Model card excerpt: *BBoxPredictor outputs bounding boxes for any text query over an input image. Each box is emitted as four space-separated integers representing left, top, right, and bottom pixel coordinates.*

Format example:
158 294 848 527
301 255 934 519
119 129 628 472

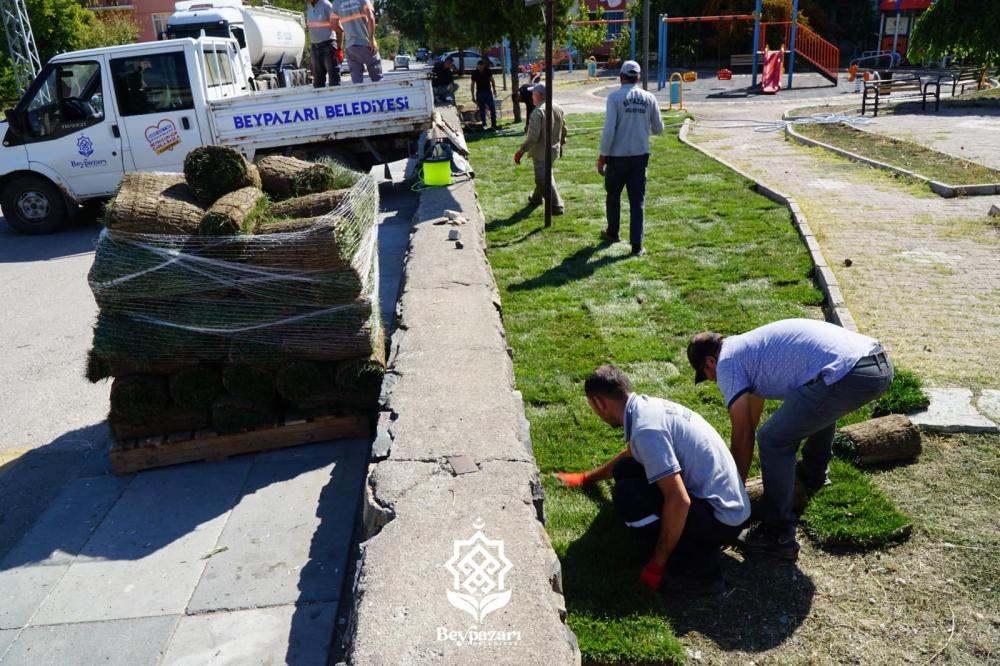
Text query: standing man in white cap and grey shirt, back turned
597 60 663 256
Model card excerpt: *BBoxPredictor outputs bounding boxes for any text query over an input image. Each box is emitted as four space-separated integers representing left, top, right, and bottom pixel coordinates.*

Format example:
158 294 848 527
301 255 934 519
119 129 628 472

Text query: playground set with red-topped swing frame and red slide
657 0 840 93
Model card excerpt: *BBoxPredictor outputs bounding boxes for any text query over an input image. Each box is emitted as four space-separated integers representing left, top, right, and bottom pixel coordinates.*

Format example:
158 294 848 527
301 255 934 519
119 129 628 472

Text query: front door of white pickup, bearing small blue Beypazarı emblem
14 56 123 200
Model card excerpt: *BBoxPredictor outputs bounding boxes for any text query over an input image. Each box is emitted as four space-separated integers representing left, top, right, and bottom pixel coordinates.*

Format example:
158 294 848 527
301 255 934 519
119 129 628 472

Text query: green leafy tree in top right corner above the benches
907 0 1000 66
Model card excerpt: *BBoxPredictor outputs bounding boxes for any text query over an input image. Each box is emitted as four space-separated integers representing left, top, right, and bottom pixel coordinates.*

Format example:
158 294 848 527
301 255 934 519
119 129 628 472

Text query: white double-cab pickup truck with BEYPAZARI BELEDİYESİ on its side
0 37 434 233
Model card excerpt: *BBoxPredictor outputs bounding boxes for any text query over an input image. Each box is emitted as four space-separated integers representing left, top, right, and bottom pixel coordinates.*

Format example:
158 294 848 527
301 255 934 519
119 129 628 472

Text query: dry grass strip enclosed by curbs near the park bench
795 124 1000 185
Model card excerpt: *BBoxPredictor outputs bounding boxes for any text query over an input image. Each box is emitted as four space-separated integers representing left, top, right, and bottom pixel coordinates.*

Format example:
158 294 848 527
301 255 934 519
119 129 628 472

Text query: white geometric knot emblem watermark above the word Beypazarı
444 518 514 622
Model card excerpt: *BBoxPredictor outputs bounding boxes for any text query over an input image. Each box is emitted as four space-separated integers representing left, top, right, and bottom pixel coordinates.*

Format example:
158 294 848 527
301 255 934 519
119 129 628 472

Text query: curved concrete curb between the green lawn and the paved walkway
677 118 858 331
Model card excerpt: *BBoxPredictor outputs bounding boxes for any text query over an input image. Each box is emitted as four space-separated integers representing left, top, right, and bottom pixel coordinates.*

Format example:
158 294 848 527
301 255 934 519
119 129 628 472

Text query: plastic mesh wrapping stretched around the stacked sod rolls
89 166 383 366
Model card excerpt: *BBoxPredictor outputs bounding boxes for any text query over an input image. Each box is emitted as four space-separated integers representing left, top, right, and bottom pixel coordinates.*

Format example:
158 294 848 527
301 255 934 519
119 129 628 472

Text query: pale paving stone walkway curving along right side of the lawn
690 103 1000 391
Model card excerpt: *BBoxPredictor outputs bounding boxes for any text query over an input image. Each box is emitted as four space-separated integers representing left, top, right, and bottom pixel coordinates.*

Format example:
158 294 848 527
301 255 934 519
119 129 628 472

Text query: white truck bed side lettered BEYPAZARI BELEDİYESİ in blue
208 72 434 154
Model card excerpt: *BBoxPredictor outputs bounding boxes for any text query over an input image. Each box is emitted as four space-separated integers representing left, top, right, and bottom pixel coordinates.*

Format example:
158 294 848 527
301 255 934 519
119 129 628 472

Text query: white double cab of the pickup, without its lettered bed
0 39 247 233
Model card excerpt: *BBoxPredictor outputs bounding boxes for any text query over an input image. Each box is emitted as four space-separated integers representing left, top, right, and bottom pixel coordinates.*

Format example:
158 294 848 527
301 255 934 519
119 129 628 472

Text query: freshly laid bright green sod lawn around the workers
469 115 912 664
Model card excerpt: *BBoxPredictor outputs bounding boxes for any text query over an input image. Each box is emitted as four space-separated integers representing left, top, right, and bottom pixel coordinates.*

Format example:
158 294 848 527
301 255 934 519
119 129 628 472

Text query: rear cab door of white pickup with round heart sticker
109 50 201 171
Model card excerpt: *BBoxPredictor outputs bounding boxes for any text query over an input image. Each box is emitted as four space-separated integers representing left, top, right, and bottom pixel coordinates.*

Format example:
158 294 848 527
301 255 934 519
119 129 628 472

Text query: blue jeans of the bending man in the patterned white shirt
757 352 893 538
